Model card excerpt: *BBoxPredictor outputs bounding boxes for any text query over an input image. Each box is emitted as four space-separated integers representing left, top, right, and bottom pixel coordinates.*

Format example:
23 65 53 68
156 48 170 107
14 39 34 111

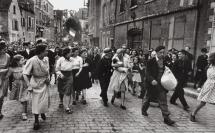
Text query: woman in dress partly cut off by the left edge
0 41 10 120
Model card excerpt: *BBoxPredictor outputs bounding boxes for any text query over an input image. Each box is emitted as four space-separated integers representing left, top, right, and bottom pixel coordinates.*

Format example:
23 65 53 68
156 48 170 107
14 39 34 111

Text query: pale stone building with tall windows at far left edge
0 0 22 42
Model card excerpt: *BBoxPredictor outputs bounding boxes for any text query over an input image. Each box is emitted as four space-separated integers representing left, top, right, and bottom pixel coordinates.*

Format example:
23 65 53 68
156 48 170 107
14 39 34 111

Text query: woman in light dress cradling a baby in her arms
108 49 129 110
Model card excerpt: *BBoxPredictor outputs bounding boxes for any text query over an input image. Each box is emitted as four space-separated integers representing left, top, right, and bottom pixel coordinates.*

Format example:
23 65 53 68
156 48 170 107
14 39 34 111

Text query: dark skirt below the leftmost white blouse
58 71 73 96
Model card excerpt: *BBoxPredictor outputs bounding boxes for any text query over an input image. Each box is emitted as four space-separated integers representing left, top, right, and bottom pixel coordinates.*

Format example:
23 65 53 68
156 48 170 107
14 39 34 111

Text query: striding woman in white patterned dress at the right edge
190 53 215 122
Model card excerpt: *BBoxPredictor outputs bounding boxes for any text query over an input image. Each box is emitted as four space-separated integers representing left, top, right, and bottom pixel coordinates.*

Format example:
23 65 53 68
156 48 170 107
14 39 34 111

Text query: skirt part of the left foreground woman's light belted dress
32 85 49 114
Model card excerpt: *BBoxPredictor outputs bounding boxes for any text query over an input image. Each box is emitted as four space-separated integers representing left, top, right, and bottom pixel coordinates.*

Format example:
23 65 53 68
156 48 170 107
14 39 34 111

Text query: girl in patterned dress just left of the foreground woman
7 55 30 121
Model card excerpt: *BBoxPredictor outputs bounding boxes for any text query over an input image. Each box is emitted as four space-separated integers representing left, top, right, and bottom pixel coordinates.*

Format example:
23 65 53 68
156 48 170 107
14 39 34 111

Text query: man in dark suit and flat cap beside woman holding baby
97 48 112 107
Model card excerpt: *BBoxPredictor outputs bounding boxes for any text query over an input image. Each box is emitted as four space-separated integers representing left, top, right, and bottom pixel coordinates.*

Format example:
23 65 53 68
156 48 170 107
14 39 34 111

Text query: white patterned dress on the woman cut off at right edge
198 66 215 103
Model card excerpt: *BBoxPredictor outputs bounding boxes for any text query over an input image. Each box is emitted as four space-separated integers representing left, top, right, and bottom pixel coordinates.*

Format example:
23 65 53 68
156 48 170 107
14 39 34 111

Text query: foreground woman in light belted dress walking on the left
23 44 50 130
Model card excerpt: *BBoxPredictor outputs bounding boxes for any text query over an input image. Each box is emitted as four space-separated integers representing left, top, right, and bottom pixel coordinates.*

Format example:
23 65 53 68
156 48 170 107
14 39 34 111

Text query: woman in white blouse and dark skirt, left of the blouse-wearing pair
56 48 74 114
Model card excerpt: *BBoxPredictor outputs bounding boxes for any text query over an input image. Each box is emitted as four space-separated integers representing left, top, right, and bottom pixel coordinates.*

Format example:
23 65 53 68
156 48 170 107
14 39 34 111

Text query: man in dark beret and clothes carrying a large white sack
142 46 175 125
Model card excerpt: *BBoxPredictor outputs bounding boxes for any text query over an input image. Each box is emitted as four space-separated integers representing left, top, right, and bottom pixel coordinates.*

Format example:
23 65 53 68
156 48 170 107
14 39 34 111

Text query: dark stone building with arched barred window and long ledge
115 0 198 53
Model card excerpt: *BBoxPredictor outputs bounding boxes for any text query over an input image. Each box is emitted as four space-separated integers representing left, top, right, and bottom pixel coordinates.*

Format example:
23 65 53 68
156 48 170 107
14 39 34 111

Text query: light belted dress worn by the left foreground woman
23 56 50 114
